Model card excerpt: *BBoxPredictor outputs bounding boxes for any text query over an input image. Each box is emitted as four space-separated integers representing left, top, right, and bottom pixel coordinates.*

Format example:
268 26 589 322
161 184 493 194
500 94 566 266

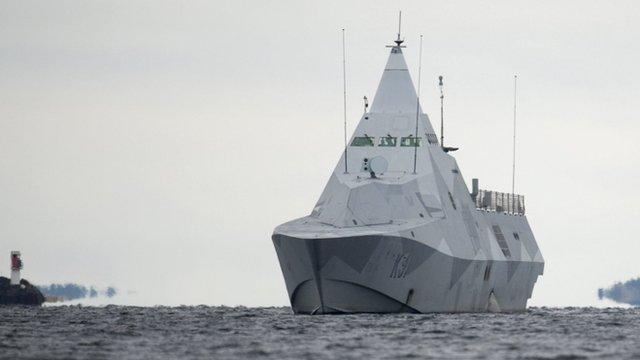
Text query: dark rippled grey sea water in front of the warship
0 306 640 359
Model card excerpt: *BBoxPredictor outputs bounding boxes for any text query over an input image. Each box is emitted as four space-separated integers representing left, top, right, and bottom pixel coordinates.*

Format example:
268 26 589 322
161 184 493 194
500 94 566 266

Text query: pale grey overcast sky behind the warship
0 1 640 305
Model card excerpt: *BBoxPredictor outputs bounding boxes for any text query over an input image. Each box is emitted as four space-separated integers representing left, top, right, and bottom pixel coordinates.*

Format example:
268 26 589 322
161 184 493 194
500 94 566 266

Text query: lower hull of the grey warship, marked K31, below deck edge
273 235 543 314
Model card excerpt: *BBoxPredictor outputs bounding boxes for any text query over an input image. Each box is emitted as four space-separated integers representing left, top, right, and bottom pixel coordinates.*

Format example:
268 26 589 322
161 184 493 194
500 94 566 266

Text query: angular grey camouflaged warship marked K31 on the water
272 26 544 314
